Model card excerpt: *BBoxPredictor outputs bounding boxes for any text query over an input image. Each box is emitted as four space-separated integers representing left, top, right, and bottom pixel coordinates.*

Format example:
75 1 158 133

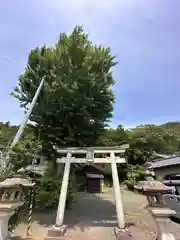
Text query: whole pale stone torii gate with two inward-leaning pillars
45 144 129 240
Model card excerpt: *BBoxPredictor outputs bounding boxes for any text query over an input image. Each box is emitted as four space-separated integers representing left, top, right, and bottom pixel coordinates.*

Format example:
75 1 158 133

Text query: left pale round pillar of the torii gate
55 153 71 227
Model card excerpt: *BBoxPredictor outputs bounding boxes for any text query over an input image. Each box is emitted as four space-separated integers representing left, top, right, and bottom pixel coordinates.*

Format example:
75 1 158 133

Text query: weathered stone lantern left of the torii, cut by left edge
0 169 34 240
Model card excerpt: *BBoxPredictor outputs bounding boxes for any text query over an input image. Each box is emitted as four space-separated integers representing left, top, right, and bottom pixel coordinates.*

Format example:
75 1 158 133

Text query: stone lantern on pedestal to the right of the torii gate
143 180 176 240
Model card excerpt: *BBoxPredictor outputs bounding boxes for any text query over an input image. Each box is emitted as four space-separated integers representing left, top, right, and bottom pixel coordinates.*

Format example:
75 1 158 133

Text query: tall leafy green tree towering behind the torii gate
13 26 116 150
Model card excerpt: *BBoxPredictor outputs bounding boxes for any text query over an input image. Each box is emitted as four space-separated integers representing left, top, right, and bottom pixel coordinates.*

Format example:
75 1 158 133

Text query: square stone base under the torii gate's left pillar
44 225 67 240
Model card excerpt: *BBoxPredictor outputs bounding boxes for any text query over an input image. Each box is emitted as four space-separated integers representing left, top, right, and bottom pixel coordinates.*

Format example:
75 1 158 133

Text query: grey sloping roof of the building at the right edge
149 156 180 169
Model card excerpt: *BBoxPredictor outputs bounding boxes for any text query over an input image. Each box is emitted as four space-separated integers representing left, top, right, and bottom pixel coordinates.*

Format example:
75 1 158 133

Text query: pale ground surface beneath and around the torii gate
16 189 180 240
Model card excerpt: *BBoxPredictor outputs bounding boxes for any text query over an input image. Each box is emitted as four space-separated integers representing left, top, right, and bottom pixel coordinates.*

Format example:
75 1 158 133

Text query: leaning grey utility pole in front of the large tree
10 77 44 149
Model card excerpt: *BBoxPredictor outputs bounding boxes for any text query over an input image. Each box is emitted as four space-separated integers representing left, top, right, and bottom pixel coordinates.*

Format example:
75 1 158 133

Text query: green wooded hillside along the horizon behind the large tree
0 122 180 154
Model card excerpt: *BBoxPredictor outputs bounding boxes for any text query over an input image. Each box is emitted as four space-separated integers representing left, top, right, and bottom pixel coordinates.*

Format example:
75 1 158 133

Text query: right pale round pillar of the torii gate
110 152 125 229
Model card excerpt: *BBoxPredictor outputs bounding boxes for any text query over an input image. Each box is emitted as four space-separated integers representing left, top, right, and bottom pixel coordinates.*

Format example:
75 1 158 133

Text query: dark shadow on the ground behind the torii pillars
30 190 117 231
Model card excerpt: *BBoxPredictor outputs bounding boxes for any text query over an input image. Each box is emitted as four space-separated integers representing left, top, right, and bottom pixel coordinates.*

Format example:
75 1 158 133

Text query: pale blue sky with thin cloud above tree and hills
0 0 180 127
